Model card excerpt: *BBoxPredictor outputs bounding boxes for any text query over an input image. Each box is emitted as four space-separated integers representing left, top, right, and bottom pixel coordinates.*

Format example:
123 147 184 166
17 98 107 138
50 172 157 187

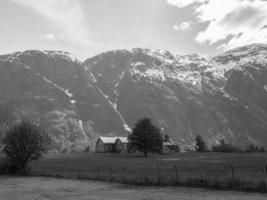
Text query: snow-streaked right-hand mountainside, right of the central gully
85 45 267 146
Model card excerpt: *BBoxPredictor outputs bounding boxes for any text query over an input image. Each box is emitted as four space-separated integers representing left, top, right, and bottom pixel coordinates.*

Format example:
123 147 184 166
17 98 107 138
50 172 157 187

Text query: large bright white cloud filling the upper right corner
167 0 267 49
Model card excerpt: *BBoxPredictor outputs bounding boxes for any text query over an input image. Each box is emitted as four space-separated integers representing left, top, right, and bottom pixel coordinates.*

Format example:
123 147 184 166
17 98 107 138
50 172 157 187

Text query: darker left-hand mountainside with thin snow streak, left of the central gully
0 51 127 152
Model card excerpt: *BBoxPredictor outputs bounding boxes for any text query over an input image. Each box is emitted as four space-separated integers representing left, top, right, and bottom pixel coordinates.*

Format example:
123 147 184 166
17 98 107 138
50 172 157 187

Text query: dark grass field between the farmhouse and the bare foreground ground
32 153 267 192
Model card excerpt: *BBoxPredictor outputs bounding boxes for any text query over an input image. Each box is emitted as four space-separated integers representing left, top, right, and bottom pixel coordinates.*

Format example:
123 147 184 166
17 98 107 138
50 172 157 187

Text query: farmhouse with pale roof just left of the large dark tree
95 137 128 153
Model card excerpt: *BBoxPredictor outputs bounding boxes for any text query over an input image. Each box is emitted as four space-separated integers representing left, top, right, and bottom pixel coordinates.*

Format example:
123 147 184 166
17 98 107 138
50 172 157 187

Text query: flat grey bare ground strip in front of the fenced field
0 176 267 200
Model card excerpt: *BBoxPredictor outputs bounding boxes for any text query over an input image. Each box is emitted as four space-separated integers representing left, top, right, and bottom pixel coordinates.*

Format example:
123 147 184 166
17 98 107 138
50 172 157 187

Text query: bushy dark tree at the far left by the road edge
3 121 50 174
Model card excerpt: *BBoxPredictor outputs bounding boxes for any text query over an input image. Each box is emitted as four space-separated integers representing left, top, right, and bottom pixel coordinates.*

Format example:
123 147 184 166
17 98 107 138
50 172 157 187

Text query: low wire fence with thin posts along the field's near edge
32 164 267 192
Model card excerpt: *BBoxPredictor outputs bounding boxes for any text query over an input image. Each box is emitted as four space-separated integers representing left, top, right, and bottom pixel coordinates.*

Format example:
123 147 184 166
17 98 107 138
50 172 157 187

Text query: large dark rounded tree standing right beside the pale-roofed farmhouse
128 118 163 157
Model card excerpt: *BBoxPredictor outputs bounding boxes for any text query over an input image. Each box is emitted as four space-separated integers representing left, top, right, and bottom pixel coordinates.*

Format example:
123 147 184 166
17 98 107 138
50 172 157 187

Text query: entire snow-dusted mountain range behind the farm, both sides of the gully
0 44 267 152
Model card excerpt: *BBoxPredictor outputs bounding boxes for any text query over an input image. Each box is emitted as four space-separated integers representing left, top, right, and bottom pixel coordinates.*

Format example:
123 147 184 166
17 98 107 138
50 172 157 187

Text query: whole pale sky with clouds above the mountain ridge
0 0 267 60
